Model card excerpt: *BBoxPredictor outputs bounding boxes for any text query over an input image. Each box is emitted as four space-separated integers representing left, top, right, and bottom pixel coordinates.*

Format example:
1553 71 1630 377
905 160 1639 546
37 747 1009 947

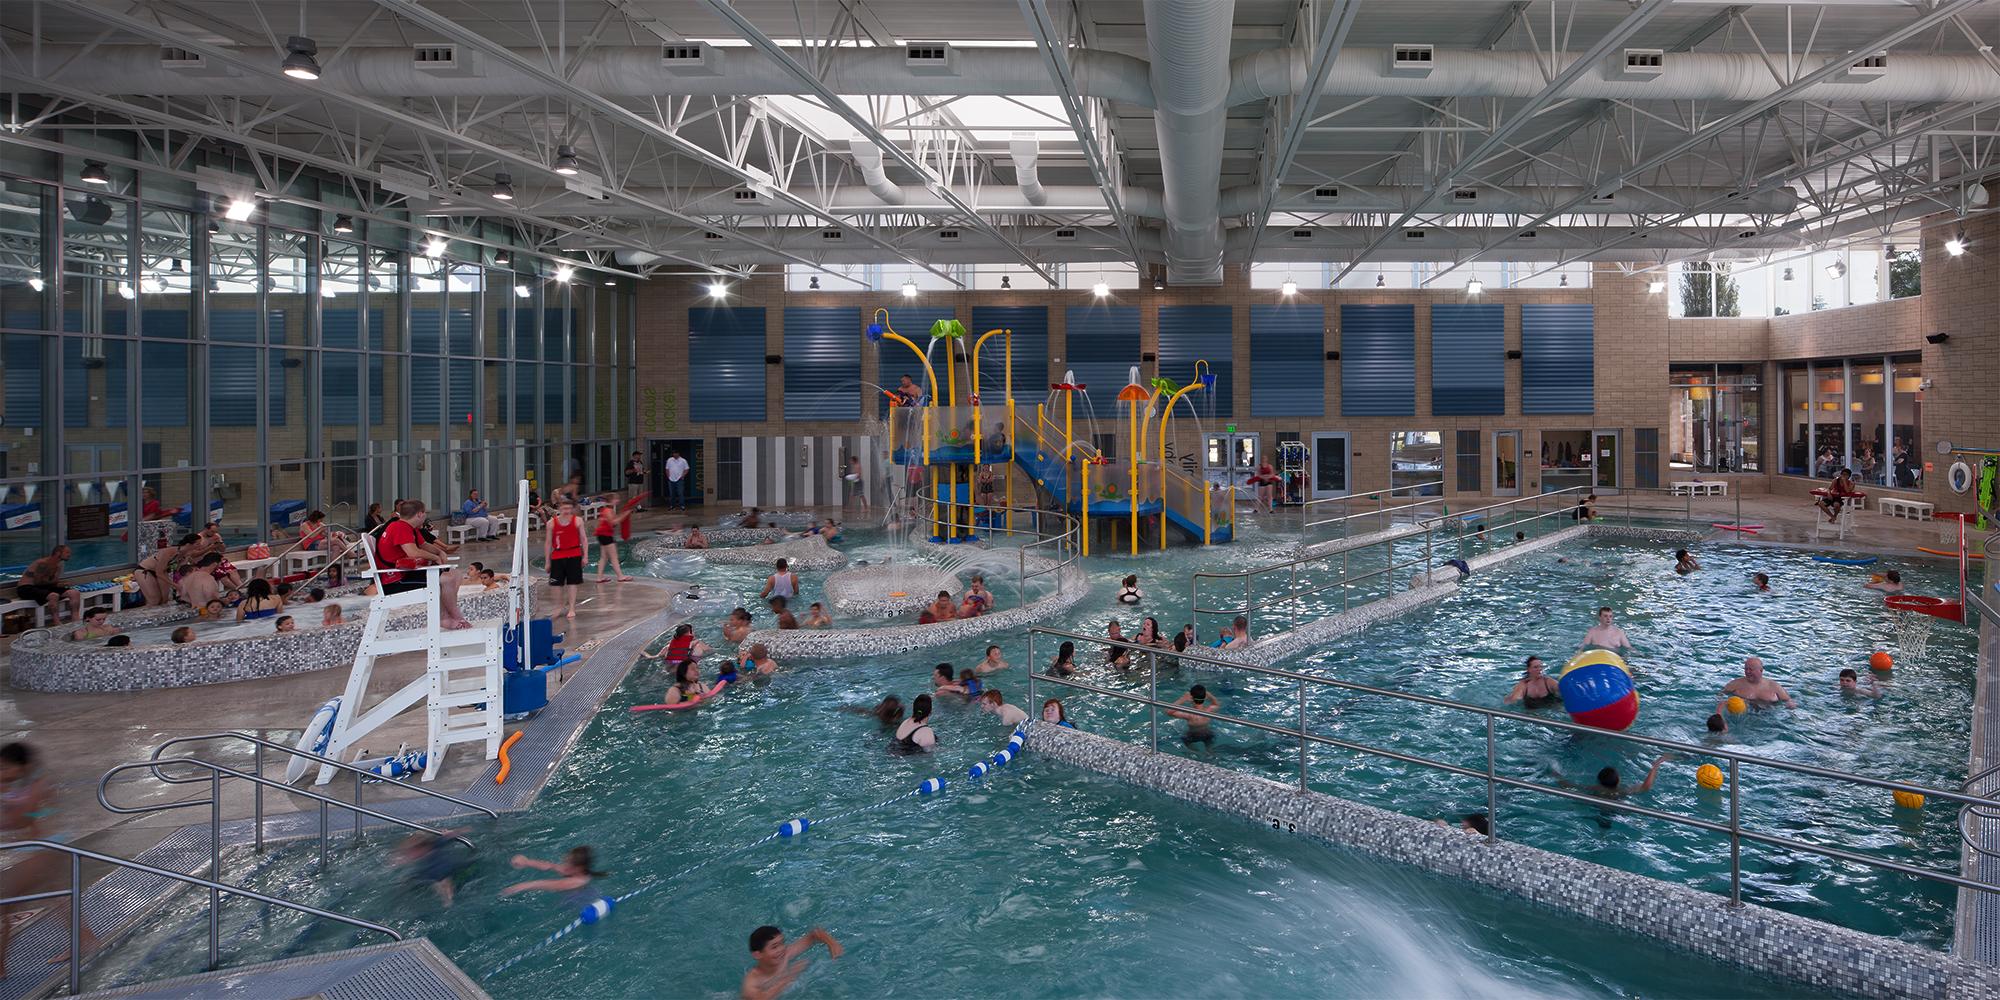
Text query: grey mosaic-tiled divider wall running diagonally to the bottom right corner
1028 722 2000 998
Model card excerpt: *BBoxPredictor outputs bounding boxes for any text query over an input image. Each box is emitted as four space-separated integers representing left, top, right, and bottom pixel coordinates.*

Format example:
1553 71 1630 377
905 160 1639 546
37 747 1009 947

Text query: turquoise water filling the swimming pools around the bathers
74 516 1972 996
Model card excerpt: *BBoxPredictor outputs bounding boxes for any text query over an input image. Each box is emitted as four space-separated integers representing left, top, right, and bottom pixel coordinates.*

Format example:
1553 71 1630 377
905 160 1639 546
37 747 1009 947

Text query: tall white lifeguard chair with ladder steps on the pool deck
302 482 528 784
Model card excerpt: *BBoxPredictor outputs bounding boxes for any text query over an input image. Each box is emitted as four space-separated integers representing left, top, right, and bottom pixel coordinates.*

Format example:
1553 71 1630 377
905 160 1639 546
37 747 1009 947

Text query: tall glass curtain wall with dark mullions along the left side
0 152 634 572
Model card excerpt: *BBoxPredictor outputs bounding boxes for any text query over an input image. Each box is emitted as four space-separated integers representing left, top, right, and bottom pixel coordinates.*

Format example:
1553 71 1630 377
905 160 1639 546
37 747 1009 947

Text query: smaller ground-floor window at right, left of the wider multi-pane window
1666 364 1764 472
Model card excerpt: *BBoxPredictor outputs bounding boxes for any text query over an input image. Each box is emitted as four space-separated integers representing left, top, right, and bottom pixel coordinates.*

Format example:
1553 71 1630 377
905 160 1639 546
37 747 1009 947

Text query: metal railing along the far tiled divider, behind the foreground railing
1188 486 1582 634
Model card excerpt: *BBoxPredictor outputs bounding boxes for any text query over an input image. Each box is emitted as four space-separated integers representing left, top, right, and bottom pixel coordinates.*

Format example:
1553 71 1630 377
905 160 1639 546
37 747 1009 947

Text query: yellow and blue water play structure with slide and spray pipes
866 310 1236 556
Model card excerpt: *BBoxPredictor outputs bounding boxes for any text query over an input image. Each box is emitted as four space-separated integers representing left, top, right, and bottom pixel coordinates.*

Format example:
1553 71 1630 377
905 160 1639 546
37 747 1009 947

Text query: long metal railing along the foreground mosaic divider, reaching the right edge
1028 626 2000 906
